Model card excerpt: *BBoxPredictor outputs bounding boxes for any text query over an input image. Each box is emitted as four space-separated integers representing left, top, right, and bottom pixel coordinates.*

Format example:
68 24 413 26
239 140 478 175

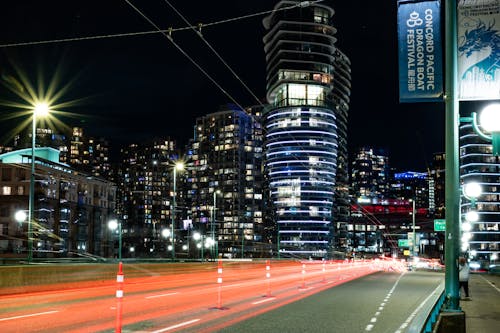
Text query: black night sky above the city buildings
0 0 490 171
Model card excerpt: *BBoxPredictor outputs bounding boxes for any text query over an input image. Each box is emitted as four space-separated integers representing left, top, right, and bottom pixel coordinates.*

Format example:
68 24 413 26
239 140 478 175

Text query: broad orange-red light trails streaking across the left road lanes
0 261 381 333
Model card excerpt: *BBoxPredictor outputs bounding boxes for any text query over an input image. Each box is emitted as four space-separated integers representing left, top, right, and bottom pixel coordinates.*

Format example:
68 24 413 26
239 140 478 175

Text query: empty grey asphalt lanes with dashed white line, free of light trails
210 271 444 333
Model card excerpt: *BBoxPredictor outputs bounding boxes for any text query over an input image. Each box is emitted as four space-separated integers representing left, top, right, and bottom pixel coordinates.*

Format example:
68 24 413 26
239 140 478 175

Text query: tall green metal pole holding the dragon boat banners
445 0 460 311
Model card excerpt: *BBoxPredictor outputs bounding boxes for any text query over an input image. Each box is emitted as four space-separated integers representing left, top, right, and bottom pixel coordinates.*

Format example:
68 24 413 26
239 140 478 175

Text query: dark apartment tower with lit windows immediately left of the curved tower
187 105 269 258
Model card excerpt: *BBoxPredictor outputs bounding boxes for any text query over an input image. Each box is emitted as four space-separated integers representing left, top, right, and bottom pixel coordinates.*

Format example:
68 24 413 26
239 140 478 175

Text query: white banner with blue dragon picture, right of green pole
457 0 500 100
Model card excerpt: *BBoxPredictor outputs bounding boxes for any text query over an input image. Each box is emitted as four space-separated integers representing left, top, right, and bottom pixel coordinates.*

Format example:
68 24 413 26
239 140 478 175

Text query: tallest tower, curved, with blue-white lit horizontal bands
263 1 350 257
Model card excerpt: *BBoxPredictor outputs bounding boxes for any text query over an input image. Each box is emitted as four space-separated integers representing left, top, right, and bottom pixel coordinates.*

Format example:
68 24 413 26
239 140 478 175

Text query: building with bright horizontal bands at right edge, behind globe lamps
460 123 500 262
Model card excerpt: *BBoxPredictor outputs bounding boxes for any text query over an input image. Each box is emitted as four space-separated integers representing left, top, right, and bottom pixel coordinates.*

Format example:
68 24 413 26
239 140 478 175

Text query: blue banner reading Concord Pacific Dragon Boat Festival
398 0 443 102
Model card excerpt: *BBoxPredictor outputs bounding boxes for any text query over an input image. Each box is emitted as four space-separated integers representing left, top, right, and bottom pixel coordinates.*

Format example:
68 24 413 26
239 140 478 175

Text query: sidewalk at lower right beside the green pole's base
460 273 500 333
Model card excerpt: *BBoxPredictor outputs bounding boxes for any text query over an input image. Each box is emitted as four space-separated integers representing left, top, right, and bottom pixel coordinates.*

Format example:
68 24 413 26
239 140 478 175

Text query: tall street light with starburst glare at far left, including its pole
27 102 50 264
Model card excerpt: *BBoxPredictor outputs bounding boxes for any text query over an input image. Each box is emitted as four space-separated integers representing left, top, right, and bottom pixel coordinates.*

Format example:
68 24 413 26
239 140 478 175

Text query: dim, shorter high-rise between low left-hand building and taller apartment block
116 139 180 257
